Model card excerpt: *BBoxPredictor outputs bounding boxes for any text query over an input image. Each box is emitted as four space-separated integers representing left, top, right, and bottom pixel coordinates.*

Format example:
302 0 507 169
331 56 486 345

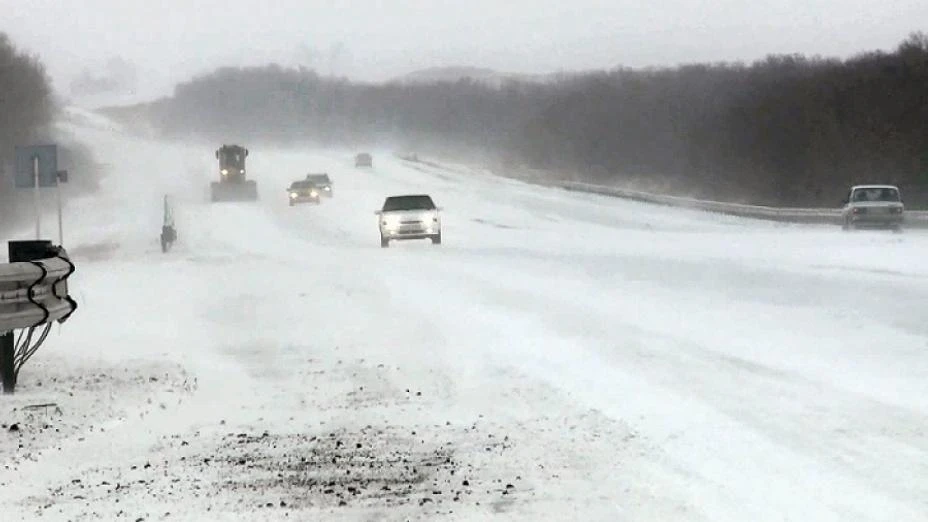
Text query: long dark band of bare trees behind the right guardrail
111 33 928 206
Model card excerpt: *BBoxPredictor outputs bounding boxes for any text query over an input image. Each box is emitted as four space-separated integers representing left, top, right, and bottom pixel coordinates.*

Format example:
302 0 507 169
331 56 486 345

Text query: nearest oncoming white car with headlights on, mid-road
376 194 441 248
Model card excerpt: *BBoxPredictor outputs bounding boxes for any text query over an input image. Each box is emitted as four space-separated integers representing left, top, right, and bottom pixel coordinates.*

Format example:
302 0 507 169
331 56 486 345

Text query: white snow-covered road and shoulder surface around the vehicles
0 110 928 521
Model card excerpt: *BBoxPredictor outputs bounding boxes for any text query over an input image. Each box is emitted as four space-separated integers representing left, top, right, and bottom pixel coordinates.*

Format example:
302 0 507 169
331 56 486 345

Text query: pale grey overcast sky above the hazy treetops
0 0 928 101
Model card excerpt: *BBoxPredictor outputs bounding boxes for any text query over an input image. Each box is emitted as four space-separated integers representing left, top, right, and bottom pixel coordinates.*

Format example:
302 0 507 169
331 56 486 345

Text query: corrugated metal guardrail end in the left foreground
0 249 77 333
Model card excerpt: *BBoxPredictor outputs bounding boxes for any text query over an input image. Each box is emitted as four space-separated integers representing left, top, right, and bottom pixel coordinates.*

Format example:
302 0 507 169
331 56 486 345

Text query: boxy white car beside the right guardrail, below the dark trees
842 185 905 232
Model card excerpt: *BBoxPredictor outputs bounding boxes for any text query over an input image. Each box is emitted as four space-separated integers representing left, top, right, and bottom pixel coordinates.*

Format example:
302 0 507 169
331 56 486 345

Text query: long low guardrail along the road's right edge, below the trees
560 181 928 228
